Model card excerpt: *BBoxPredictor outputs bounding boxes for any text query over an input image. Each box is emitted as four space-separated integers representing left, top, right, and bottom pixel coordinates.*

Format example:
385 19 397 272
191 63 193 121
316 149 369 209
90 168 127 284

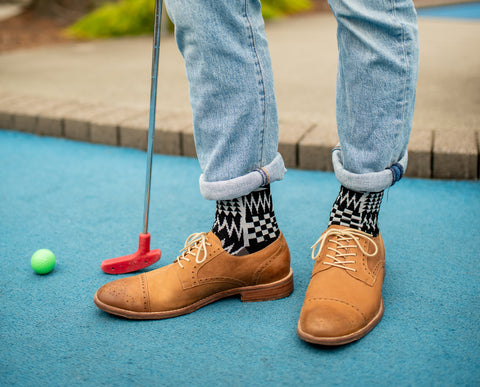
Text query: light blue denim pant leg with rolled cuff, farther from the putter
329 0 418 192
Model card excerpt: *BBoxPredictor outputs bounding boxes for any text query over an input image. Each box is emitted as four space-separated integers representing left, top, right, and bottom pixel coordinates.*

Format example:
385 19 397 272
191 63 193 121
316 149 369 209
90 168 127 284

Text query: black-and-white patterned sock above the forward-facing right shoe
328 186 383 236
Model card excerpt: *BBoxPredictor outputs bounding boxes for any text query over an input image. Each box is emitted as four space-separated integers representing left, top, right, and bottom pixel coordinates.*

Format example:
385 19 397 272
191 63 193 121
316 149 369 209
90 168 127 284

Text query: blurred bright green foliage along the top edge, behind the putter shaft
66 0 312 39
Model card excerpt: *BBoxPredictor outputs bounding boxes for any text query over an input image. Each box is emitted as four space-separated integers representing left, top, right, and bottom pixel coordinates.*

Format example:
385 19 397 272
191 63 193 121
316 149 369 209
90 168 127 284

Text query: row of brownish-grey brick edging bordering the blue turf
0 94 480 180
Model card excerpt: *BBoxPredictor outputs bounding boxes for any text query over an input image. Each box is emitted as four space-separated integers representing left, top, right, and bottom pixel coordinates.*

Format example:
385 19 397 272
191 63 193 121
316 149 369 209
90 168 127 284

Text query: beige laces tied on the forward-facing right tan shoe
312 228 378 271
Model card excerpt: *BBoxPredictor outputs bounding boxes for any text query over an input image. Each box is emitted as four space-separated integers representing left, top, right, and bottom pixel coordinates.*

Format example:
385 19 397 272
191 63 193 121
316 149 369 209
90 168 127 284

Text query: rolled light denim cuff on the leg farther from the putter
332 147 408 192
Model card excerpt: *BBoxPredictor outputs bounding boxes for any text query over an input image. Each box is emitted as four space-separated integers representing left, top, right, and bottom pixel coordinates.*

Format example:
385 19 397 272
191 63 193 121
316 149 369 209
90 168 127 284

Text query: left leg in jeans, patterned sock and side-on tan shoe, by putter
91 0 293 319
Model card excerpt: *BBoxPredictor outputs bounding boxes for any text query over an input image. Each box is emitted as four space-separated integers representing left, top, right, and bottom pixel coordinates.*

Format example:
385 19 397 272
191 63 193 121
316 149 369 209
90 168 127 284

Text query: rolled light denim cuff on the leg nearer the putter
200 153 287 200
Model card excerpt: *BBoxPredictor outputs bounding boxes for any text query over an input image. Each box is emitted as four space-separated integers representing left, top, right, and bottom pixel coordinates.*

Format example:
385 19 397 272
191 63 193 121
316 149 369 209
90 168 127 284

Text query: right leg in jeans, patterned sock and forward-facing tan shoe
298 0 418 345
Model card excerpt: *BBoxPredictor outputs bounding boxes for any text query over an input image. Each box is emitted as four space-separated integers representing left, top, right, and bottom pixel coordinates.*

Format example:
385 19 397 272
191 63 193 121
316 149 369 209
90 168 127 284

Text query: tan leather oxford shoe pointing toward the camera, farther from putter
297 225 385 345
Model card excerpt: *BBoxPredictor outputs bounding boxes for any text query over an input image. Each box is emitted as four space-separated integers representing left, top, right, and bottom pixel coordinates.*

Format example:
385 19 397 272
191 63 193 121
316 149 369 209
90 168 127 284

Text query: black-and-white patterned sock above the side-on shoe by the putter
212 185 280 255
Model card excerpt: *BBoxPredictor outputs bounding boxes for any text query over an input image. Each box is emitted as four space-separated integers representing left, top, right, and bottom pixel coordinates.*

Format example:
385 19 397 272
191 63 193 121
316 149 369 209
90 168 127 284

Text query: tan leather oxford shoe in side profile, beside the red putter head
94 232 293 319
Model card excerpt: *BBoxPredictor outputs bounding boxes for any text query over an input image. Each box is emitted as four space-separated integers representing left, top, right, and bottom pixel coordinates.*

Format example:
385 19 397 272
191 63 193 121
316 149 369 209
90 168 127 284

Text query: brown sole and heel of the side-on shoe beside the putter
93 269 293 320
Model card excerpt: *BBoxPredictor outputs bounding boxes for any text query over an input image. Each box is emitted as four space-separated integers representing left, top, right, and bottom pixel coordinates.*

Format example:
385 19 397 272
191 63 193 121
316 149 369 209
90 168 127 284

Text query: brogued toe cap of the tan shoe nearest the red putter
96 277 146 312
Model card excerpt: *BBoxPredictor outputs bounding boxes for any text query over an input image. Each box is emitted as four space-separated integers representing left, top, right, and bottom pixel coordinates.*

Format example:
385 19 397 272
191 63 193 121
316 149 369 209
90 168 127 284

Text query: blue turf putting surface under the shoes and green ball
0 131 480 386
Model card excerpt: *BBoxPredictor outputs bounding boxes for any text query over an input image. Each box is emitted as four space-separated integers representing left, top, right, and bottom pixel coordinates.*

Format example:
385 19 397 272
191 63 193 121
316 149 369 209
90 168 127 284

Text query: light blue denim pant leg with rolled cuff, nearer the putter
165 0 286 200
